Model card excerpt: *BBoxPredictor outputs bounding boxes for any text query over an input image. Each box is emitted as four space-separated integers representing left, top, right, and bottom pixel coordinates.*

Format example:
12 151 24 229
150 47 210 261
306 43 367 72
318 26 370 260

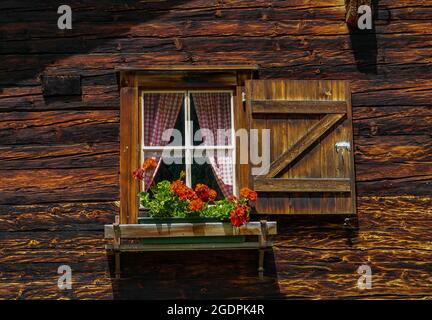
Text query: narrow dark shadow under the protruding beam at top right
348 0 379 74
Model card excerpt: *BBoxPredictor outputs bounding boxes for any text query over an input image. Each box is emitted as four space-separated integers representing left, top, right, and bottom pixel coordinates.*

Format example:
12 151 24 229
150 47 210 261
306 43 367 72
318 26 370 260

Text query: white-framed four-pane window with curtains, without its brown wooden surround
140 90 236 198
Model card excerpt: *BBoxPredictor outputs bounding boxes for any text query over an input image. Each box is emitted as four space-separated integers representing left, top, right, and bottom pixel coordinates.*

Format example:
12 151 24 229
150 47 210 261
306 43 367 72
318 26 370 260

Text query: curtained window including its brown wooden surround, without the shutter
117 65 257 224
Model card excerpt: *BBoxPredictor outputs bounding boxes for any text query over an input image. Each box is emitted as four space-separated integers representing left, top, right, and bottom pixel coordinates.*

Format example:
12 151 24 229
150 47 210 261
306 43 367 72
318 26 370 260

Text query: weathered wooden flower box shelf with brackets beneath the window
105 220 277 278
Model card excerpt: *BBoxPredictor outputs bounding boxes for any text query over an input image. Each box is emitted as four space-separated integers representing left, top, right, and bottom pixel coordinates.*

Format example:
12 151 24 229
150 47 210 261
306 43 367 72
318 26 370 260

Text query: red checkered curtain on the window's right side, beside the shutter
192 92 234 197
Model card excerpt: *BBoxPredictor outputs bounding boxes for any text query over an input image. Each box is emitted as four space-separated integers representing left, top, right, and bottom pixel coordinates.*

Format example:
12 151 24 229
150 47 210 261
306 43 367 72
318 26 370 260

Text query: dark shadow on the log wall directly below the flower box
109 250 282 300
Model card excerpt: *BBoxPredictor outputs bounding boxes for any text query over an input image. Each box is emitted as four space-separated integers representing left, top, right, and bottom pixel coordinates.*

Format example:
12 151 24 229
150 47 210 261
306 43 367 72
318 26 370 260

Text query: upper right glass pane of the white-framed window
190 92 233 146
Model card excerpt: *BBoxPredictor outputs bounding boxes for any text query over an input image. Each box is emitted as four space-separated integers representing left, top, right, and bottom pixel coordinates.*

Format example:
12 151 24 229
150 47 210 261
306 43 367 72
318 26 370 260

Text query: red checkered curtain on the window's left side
143 93 184 191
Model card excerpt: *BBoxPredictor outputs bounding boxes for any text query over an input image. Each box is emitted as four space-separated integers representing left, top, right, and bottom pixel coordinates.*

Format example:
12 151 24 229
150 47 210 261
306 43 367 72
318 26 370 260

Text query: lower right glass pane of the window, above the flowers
192 150 234 200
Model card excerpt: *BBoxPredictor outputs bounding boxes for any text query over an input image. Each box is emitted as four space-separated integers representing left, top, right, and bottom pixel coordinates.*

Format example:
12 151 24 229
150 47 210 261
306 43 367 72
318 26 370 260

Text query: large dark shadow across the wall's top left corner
0 0 194 92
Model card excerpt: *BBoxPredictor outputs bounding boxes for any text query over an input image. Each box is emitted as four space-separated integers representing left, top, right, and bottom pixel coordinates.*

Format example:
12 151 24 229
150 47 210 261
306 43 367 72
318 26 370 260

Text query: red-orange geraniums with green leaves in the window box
133 158 257 243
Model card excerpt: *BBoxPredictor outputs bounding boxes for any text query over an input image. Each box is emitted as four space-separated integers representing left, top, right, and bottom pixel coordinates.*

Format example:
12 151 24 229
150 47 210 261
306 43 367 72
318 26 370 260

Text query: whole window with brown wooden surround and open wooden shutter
119 65 356 224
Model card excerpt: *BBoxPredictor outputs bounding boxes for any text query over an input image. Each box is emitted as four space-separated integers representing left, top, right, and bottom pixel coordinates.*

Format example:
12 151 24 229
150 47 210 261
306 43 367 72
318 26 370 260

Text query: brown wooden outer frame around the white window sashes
116 65 258 224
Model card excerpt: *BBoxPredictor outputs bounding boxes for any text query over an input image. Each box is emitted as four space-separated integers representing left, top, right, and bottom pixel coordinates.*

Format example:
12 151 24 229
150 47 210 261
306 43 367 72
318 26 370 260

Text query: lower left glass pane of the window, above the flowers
144 150 186 190
